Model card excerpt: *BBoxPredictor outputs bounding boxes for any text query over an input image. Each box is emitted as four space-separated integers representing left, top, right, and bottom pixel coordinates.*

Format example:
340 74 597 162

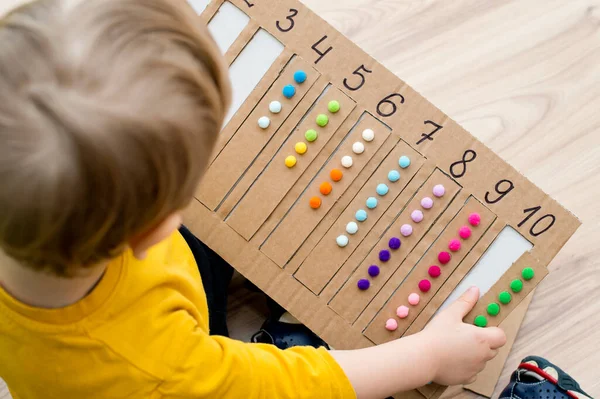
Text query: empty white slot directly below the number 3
223 29 284 126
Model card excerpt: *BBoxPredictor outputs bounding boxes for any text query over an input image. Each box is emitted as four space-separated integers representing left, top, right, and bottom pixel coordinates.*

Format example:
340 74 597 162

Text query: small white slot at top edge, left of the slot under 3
208 1 250 54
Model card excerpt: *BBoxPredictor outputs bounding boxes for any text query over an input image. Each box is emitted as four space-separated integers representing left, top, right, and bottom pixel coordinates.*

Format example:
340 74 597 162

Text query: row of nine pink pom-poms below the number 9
385 213 481 331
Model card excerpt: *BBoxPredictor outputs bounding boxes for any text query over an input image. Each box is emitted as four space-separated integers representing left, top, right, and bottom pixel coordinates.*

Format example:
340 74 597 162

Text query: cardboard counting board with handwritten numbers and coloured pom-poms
186 0 580 398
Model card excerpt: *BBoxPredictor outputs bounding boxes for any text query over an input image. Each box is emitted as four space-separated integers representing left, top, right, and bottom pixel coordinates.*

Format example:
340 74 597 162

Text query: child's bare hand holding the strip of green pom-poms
424 287 506 385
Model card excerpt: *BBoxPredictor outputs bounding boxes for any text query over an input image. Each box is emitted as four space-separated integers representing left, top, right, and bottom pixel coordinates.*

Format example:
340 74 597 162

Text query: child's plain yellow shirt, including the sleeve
0 233 355 399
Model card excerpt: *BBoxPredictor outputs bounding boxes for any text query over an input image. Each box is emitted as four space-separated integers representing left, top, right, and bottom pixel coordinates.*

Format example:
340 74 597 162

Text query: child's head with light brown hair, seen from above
0 0 230 276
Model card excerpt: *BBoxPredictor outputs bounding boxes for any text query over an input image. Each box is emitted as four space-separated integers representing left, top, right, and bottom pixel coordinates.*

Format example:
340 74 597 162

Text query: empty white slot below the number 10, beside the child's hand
436 226 533 314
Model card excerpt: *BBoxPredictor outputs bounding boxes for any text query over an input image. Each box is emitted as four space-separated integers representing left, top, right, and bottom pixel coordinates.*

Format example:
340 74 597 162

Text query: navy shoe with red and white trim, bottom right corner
500 356 592 399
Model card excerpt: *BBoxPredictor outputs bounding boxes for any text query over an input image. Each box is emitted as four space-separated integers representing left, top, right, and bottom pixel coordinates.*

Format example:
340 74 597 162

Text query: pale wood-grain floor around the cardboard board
0 0 600 398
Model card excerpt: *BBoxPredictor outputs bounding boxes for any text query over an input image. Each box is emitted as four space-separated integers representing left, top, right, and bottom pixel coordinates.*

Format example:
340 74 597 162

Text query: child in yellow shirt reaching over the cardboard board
0 0 505 399
